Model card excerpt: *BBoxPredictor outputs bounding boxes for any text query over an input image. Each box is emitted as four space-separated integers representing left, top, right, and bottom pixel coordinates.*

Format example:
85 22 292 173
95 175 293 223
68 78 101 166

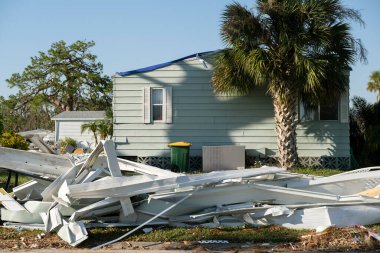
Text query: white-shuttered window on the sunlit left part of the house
143 87 173 124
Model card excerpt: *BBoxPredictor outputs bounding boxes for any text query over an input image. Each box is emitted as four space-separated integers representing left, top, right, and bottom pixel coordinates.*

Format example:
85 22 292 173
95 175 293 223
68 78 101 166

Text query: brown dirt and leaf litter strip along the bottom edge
0 227 380 253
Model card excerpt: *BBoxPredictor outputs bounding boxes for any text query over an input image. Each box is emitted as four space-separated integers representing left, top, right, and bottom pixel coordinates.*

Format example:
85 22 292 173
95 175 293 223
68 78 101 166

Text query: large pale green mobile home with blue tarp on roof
113 52 350 168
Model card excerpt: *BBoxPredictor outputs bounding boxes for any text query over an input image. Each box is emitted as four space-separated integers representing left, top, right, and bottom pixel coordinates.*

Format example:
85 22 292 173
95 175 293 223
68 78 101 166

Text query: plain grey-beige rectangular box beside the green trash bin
202 145 245 171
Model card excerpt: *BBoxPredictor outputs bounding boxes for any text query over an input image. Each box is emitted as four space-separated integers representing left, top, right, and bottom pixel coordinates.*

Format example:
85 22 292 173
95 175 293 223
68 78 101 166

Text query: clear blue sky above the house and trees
0 0 380 103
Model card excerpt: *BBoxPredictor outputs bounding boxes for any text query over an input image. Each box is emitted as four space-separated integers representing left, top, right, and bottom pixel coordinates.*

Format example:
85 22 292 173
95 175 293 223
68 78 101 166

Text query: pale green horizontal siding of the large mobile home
113 55 349 168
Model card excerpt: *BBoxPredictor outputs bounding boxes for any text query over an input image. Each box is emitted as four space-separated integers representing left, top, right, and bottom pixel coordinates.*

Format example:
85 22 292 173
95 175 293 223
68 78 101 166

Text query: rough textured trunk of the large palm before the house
272 89 298 169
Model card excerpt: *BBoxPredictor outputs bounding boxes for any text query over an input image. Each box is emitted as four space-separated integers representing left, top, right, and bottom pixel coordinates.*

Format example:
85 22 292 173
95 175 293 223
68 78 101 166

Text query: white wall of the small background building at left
56 120 95 143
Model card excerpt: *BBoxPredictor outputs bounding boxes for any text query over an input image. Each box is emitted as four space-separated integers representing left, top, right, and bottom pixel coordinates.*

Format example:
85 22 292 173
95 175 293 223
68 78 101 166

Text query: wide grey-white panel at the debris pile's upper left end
0 147 72 179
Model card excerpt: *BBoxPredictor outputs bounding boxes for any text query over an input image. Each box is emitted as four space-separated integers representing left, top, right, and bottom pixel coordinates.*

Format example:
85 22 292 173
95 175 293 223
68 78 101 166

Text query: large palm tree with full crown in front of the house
212 0 366 168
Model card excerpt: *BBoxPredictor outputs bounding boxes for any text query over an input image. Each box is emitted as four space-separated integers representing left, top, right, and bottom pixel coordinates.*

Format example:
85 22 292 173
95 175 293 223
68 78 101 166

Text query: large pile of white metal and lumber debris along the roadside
0 140 380 247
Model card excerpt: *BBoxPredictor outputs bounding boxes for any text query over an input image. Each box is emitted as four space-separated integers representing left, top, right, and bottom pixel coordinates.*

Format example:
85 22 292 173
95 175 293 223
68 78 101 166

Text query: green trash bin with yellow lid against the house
168 141 191 172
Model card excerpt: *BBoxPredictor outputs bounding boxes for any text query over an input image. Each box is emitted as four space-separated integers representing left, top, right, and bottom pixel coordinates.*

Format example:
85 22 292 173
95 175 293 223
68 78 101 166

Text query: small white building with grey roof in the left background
52 111 106 143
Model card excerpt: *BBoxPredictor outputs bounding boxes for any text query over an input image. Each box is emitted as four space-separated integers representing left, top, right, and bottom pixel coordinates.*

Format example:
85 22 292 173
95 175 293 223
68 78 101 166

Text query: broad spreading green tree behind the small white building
7 41 112 112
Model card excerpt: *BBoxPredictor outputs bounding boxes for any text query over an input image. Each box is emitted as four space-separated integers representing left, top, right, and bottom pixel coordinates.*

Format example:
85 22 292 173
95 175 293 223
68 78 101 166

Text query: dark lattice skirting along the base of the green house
134 156 350 170
